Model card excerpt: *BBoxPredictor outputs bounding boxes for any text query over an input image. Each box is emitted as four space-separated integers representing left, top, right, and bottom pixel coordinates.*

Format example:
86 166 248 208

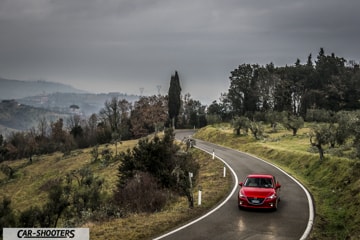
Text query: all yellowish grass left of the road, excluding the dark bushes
0 138 233 240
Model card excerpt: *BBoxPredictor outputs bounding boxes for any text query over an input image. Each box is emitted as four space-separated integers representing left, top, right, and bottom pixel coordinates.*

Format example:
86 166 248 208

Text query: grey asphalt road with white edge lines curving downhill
156 130 313 240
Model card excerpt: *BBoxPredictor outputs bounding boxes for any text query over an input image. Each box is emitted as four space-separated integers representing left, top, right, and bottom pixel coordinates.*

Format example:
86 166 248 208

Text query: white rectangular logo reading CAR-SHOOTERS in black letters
3 228 90 240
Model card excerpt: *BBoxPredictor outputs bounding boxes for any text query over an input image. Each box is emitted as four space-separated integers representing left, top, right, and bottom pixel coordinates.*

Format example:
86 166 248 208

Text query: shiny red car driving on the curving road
238 174 281 210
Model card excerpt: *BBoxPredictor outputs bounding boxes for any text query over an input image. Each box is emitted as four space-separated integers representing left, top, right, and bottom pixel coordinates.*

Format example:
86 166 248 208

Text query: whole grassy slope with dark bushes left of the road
0 130 233 240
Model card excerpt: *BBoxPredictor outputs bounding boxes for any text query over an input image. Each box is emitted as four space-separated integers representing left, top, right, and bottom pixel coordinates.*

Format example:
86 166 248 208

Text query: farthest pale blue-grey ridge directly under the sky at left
0 78 86 100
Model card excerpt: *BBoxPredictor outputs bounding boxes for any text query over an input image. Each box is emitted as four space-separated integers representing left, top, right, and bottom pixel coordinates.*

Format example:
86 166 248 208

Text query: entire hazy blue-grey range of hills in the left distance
0 78 139 135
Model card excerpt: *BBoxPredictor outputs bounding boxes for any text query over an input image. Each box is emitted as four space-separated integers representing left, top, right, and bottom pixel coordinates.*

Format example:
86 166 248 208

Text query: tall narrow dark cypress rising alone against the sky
168 71 181 128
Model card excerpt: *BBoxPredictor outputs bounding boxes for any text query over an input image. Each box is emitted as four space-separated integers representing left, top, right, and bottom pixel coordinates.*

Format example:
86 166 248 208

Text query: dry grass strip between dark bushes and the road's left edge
86 150 232 240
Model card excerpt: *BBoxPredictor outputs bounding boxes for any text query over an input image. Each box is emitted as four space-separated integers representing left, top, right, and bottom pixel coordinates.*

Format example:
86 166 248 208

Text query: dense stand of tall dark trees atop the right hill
227 48 360 118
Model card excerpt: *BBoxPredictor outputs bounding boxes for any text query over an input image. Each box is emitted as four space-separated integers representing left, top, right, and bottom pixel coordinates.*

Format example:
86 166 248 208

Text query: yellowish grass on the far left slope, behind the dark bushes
0 141 137 211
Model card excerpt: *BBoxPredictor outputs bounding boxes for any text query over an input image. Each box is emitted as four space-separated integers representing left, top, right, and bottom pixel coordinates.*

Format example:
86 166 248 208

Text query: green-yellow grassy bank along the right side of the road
196 125 360 239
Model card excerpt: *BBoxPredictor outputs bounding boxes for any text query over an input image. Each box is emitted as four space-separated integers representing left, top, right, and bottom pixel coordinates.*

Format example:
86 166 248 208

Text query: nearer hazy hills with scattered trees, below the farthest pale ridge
0 93 139 135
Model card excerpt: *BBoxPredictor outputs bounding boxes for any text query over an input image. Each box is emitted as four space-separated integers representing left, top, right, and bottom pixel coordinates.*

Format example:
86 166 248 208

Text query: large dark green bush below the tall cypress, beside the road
118 129 199 209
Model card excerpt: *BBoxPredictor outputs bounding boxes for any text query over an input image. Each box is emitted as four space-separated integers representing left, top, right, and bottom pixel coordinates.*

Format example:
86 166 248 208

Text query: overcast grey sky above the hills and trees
0 0 360 104
